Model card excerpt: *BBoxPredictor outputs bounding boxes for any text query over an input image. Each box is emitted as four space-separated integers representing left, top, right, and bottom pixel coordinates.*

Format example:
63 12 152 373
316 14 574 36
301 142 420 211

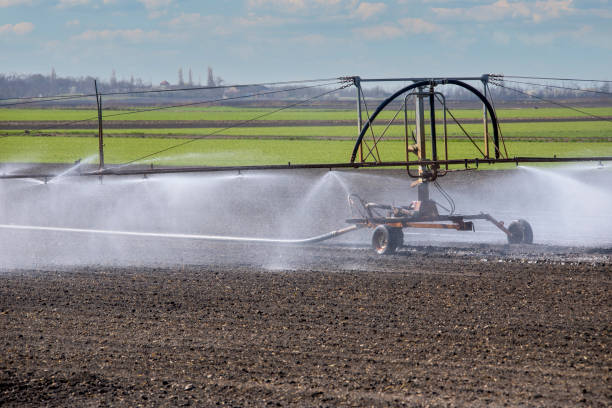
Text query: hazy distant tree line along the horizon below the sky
0 67 610 104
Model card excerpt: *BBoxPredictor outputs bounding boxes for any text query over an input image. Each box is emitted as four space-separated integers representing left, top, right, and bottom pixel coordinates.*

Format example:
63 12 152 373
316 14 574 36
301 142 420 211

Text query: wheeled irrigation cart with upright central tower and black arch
346 75 533 255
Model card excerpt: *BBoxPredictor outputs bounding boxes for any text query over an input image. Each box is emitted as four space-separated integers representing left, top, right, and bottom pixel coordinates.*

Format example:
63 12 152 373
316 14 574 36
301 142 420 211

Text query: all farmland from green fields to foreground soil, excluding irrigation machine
0 103 612 407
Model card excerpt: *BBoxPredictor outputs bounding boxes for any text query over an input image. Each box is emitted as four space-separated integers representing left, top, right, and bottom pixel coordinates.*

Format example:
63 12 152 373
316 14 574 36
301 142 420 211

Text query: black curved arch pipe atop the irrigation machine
351 79 500 163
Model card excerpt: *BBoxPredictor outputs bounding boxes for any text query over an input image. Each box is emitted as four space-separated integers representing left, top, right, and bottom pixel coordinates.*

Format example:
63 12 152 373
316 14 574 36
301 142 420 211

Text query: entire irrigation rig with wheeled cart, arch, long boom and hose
0 74 612 254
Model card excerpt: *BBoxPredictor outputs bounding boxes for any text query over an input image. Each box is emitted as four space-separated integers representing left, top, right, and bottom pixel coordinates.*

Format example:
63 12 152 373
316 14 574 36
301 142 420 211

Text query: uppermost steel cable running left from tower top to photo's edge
0 78 340 107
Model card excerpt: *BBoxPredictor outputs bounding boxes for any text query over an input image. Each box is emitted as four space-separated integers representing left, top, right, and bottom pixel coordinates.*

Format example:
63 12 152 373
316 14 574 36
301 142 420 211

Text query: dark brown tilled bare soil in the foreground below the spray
0 244 612 407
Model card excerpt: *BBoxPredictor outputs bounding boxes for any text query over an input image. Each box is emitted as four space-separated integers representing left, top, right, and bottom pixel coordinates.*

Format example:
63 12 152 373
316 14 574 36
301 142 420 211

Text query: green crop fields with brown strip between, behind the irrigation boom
0 106 612 166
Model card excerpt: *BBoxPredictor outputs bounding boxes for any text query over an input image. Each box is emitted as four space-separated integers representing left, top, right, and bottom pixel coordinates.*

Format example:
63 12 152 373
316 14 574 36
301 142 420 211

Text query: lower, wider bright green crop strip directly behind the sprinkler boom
0 136 612 166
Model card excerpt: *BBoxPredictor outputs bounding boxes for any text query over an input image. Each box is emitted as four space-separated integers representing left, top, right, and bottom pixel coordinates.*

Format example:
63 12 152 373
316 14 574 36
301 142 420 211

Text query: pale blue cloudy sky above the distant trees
0 0 612 84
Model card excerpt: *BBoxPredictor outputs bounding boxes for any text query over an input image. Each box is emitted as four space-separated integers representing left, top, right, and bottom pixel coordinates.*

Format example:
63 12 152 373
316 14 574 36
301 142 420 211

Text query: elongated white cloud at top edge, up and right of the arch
432 0 575 23
